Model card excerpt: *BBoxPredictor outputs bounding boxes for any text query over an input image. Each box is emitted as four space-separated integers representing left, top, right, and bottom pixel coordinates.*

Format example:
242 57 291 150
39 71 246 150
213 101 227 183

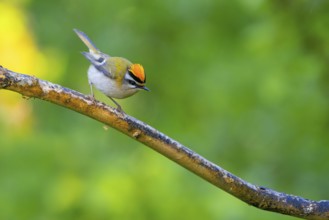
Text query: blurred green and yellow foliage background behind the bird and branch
0 0 329 220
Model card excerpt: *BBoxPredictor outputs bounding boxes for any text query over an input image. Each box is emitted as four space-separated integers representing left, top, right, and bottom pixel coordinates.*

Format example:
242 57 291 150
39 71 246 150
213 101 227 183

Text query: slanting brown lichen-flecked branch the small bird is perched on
0 66 329 219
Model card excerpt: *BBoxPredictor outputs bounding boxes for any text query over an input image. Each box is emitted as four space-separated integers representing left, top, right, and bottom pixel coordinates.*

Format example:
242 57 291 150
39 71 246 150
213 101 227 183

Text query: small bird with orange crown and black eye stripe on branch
74 29 149 111
